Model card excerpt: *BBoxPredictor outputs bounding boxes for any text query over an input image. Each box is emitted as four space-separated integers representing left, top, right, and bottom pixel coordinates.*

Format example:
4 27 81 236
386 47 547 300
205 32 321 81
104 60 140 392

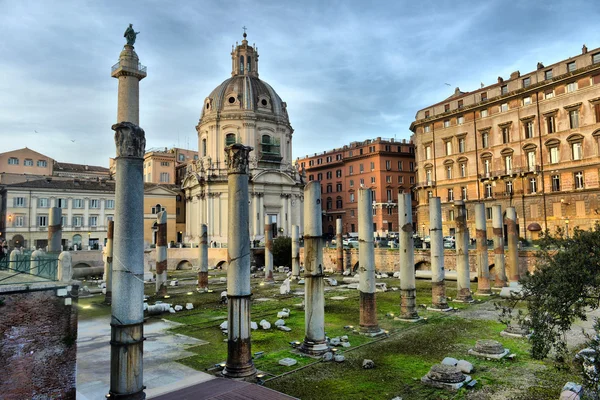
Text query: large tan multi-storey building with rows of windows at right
410 46 600 239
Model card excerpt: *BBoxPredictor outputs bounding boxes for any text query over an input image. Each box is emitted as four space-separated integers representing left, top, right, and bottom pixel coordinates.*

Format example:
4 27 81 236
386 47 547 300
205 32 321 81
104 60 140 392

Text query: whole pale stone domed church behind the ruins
182 33 304 246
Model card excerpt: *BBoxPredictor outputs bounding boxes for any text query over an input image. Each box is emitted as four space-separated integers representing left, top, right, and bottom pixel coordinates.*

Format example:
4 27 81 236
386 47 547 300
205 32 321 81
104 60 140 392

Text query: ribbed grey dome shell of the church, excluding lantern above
202 75 288 122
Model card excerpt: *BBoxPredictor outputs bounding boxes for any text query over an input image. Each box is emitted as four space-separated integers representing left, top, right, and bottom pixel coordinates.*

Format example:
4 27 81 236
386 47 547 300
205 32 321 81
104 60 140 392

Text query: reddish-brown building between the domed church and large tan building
296 138 415 236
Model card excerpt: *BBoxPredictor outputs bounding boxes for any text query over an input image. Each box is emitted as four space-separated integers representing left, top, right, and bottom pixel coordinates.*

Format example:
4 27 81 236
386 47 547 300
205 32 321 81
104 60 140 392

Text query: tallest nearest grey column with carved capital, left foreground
109 122 146 399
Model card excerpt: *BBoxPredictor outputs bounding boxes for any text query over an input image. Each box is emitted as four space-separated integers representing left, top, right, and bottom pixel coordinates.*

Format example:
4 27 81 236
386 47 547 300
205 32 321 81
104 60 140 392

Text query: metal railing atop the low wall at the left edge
0 251 58 285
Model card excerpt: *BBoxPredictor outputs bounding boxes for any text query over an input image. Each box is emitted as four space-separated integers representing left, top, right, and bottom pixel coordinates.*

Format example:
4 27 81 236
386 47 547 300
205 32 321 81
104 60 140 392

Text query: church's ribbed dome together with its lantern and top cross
200 33 289 124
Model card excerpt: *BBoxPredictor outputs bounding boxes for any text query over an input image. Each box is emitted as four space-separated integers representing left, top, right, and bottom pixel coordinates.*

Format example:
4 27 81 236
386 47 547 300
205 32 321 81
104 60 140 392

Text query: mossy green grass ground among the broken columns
80 271 578 400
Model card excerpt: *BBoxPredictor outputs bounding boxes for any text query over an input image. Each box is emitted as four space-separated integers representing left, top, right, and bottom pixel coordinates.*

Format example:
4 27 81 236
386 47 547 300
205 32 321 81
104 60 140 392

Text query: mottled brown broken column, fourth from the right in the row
454 200 473 303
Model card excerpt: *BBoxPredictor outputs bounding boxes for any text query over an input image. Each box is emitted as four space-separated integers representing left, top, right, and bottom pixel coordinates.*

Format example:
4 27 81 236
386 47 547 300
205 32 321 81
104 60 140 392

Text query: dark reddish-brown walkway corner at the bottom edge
153 378 297 400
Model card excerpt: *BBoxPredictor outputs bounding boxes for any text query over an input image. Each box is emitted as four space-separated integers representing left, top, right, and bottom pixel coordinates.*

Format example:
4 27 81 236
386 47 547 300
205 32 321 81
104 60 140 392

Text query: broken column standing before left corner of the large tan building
398 193 419 320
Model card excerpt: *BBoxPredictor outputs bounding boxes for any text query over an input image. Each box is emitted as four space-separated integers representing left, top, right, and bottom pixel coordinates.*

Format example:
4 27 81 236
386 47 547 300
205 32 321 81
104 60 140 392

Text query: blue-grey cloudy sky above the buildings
0 0 600 166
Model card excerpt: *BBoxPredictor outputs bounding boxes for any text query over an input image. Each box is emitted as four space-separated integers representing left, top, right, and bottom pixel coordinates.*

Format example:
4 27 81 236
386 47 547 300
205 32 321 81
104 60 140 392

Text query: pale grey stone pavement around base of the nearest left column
77 316 215 400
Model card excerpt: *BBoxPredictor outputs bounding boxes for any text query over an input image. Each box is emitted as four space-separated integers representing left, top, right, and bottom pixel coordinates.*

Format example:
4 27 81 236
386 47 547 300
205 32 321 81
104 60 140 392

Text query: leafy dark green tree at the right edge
500 224 600 360
